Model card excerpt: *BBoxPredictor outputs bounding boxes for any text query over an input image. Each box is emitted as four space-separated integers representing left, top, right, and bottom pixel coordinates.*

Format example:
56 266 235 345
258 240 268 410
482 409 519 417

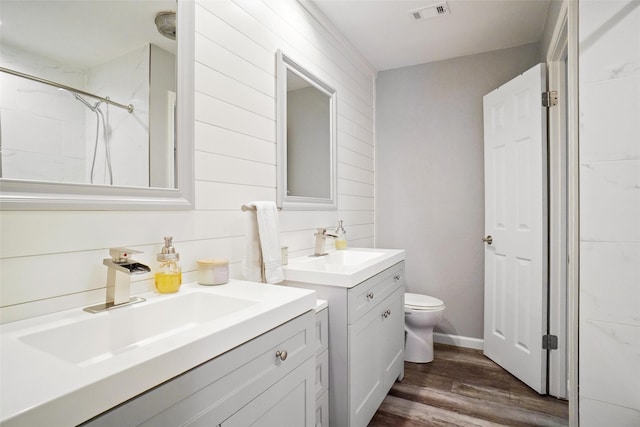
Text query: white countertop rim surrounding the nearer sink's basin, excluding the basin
0 280 317 427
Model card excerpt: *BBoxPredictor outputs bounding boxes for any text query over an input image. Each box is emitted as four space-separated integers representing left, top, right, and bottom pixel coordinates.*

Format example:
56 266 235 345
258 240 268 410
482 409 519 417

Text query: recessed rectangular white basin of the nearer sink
19 292 257 366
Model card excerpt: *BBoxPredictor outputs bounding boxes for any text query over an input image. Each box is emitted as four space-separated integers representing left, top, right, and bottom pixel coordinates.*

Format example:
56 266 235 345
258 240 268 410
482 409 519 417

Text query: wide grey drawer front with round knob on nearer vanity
82 311 315 427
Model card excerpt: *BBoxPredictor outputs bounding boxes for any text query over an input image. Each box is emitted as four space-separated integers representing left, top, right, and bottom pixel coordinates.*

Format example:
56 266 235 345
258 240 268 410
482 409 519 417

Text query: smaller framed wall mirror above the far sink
277 51 337 210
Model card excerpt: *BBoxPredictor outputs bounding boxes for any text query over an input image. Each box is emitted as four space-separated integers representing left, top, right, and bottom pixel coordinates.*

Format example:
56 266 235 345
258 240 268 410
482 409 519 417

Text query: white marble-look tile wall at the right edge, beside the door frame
579 0 640 427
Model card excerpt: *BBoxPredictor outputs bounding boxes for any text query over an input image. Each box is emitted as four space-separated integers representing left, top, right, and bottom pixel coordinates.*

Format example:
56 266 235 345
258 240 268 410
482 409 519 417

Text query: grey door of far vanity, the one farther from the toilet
349 306 385 426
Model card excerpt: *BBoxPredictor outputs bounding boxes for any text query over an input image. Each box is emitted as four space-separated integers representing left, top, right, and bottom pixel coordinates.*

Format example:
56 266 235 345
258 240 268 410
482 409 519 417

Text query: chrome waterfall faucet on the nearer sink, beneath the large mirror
84 248 151 313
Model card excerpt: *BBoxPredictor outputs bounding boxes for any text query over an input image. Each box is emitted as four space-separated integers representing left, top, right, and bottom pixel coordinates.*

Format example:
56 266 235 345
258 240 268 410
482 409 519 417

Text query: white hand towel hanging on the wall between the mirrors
245 202 284 283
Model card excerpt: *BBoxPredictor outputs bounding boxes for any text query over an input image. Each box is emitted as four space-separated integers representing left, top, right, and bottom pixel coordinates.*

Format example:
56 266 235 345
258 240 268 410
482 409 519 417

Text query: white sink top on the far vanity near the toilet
283 248 404 288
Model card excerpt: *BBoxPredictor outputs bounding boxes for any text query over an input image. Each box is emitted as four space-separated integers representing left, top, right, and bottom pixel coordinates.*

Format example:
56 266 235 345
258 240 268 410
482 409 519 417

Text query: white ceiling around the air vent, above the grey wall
303 0 551 71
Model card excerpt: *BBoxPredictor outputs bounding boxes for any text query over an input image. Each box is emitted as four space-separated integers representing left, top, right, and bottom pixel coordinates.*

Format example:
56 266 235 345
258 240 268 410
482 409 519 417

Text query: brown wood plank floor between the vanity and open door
369 344 569 427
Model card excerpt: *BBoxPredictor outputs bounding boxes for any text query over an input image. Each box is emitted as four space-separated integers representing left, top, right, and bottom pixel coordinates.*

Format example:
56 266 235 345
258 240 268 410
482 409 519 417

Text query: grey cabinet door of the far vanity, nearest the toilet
379 288 404 390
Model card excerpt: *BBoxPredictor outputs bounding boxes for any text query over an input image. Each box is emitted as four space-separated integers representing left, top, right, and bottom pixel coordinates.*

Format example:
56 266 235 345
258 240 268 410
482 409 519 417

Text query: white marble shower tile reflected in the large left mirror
0 45 149 187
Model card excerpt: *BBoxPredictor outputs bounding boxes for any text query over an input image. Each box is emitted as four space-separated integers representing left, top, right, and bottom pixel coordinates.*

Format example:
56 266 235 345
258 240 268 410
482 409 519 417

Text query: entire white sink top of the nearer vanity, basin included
0 280 316 427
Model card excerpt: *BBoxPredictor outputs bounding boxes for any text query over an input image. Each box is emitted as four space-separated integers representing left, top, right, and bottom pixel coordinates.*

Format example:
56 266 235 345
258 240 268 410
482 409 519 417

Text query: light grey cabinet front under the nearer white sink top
83 311 316 427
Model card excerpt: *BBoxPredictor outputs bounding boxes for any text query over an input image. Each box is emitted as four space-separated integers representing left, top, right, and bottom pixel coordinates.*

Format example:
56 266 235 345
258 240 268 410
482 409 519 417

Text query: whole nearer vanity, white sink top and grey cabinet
0 280 319 427
